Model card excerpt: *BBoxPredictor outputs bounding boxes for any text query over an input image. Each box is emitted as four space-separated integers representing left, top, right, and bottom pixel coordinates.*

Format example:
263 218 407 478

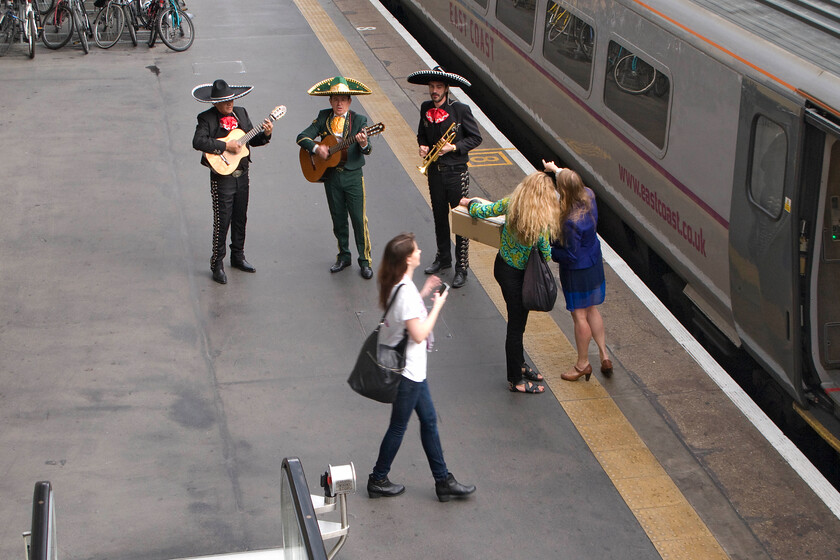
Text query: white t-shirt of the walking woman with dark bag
379 276 428 382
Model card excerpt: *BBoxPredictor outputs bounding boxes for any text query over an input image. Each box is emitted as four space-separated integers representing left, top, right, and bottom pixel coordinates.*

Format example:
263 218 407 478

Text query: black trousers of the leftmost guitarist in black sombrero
210 169 248 270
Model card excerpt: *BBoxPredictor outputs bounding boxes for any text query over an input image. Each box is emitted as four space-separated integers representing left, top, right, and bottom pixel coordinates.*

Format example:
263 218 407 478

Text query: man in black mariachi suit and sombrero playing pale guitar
192 80 272 284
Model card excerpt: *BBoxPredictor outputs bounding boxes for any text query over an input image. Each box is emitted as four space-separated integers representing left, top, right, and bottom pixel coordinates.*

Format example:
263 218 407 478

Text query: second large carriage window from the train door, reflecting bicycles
543 0 595 90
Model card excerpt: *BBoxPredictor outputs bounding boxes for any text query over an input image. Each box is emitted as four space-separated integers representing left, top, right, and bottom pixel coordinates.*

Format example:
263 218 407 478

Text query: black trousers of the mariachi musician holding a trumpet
428 163 470 270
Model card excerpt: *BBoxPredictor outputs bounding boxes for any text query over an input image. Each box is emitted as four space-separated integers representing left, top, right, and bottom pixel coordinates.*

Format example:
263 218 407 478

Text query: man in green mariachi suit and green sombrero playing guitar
297 76 373 280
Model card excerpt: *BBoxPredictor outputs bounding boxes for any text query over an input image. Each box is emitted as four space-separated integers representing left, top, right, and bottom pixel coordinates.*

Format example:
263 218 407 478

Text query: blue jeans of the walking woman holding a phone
373 377 449 481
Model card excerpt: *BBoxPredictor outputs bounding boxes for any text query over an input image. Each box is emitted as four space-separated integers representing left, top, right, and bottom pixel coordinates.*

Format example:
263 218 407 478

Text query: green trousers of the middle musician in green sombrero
324 168 371 266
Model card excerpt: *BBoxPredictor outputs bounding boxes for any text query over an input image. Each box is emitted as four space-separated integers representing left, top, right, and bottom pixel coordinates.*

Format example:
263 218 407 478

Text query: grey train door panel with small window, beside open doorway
729 78 803 402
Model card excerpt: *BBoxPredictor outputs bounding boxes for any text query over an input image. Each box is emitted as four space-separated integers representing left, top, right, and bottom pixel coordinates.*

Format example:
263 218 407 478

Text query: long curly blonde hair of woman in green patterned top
506 171 561 246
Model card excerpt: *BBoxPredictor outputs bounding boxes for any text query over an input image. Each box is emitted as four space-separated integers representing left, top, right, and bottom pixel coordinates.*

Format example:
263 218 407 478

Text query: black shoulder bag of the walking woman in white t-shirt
347 284 408 403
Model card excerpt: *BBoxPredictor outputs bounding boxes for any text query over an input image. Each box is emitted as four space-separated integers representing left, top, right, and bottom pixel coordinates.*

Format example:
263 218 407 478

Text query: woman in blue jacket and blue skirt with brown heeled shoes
543 161 612 381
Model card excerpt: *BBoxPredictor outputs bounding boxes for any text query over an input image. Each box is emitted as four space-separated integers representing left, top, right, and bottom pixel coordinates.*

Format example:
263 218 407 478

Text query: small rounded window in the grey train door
750 116 787 217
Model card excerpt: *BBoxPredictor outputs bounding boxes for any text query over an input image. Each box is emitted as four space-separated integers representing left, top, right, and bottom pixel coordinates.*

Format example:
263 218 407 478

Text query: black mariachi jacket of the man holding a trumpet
417 94 482 165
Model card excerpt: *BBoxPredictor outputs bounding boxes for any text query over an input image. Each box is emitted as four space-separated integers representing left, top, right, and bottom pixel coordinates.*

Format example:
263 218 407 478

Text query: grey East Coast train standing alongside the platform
398 0 840 420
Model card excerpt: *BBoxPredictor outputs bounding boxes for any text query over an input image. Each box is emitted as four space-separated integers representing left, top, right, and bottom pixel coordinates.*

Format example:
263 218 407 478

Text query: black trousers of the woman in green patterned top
493 253 528 384
